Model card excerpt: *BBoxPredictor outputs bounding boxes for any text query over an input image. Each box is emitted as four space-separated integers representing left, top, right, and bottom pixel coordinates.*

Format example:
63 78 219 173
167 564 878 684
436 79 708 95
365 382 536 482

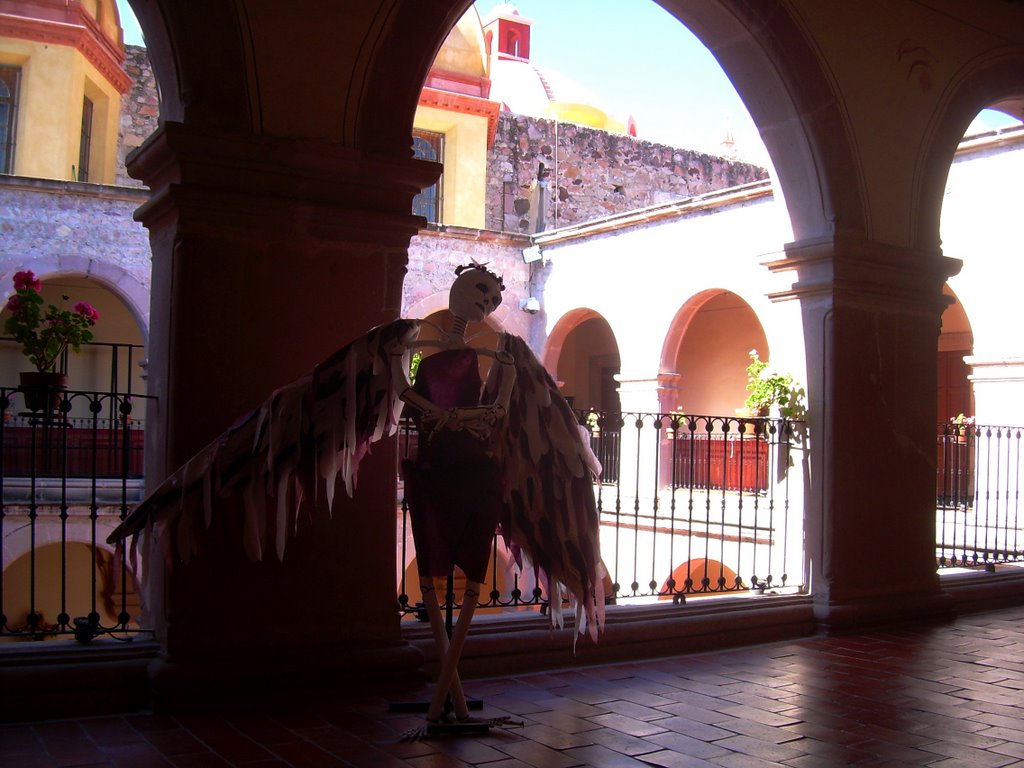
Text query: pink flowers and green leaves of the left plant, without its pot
3 270 99 373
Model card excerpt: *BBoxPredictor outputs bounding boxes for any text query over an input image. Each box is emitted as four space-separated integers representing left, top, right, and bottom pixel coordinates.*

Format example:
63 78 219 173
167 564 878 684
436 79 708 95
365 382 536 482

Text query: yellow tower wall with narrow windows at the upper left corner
0 38 121 184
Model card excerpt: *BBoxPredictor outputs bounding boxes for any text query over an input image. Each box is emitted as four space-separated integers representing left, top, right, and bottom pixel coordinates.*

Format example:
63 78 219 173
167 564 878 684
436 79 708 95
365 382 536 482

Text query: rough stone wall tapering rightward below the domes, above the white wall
486 113 768 232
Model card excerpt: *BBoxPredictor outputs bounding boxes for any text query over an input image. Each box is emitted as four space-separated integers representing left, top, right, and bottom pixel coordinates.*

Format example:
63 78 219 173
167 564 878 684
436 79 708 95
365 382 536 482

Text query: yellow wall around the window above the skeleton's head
413 105 487 229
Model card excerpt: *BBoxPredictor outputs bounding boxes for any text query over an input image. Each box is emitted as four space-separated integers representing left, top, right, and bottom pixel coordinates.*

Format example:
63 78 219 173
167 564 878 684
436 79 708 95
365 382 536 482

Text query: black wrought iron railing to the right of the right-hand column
935 423 1024 570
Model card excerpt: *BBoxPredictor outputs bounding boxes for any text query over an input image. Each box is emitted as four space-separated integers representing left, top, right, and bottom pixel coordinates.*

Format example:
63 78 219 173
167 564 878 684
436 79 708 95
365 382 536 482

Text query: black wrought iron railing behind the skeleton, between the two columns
398 412 805 618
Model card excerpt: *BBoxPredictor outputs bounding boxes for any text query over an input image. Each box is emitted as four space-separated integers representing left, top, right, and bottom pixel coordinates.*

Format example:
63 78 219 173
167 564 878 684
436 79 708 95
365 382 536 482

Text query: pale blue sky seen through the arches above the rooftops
117 0 1016 165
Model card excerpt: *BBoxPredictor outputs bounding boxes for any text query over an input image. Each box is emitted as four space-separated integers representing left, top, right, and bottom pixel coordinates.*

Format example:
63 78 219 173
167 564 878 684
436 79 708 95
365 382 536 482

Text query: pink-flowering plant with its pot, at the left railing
3 270 99 411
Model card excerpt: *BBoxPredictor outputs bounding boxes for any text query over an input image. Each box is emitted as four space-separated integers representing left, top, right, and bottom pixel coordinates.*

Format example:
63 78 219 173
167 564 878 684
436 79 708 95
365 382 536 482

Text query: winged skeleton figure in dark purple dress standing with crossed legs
109 264 604 737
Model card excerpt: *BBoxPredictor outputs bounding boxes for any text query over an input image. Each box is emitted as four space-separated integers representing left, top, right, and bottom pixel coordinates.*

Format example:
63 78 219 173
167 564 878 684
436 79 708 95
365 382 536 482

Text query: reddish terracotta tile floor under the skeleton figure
6 607 1024 768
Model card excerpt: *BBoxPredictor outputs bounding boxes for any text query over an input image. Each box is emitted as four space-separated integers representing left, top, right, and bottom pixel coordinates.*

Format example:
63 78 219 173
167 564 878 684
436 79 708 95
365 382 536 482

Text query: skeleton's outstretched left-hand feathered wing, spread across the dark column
108 321 420 564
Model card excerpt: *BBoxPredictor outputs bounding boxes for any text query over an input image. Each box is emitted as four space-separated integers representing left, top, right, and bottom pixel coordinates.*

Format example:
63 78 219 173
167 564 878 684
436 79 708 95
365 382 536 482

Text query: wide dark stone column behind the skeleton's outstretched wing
129 123 437 701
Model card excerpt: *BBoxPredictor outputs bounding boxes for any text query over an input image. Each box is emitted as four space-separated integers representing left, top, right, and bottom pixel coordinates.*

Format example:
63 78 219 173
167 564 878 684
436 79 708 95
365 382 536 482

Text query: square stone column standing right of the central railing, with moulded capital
770 238 958 627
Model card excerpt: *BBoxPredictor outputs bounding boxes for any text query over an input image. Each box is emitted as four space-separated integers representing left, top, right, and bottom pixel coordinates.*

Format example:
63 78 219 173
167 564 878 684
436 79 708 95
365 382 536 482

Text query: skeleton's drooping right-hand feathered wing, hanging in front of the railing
483 334 604 639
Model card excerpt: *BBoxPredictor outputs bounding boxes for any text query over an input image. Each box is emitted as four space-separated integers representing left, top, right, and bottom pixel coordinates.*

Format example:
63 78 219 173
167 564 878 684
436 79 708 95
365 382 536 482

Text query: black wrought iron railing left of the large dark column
0 388 150 642
